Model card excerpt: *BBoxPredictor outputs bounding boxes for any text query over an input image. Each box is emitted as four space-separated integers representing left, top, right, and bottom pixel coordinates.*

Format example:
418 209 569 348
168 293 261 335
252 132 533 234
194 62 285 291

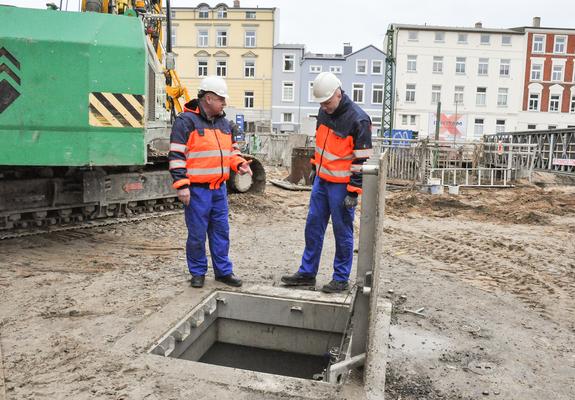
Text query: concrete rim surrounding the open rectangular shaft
110 283 391 400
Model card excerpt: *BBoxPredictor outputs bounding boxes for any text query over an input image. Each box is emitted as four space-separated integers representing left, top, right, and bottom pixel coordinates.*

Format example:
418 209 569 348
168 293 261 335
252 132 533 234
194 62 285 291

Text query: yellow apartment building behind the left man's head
172 0 279 129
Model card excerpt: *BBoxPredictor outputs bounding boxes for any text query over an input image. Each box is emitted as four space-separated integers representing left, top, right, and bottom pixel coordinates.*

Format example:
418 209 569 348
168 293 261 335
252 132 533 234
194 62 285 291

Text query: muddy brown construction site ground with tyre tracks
0 167 575 400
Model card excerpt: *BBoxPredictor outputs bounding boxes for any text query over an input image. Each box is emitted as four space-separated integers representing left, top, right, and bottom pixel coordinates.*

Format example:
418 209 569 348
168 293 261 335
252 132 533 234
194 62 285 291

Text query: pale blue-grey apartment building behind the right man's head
272 43 385 135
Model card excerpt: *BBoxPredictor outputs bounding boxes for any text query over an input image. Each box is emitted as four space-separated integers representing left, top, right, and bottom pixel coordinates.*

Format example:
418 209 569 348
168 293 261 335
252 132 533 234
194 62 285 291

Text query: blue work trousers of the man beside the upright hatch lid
299 177 355 281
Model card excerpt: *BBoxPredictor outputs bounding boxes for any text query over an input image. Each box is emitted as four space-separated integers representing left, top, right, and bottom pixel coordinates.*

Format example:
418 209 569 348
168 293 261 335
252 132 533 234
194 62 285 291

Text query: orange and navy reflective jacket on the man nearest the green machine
168 99 246 189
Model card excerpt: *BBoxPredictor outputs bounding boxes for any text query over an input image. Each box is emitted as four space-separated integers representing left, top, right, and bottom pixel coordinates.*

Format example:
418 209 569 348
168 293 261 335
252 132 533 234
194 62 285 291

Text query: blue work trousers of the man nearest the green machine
184 184 233 277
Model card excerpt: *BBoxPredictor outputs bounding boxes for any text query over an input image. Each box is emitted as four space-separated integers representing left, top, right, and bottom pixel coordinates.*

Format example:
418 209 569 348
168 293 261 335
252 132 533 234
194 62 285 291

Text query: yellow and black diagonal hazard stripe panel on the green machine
89 92 144 128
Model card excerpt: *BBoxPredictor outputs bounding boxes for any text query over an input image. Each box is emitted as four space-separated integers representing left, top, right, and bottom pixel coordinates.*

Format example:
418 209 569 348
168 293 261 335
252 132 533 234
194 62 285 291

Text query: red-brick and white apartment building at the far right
519 17 575 130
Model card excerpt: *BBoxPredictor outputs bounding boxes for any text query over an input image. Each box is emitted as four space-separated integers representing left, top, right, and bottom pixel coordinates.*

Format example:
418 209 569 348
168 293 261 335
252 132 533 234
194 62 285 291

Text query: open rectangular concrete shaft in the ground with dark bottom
149 291 349 379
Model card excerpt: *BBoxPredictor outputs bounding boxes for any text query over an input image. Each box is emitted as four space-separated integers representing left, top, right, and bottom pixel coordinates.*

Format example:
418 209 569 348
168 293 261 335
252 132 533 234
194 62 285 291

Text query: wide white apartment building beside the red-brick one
392 23 525 140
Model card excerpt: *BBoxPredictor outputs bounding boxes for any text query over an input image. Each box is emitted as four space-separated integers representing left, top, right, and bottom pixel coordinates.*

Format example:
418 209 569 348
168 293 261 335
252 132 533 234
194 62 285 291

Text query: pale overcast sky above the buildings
4 0 575 53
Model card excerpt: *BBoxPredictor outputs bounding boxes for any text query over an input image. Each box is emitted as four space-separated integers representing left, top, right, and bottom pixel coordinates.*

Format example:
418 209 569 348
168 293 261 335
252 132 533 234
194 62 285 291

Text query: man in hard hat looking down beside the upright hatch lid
281 72 372 293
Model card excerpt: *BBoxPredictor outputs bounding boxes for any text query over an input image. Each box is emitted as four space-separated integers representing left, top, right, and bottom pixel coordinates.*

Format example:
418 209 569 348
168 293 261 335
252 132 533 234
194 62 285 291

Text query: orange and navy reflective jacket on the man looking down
312 93 373 194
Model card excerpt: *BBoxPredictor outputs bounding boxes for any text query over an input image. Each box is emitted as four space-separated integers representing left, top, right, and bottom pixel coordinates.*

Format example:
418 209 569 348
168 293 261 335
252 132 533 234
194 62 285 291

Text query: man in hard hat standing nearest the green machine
169 76 252 288
